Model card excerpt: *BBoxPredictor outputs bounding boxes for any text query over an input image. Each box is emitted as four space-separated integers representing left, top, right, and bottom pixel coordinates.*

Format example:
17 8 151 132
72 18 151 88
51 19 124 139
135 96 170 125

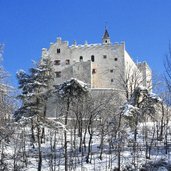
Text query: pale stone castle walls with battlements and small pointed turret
42 29 152 91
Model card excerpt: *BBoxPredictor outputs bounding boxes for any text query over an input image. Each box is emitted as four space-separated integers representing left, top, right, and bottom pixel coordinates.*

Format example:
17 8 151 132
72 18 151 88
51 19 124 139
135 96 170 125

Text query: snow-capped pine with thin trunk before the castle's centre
56 78 88 171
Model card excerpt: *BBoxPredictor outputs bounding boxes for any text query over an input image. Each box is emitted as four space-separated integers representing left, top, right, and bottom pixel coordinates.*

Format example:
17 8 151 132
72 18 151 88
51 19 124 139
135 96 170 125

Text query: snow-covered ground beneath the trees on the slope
1 122 171 171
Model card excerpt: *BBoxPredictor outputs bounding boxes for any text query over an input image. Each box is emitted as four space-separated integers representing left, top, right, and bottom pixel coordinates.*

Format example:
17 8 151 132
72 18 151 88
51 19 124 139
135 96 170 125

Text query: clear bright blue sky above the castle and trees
0 0 171 85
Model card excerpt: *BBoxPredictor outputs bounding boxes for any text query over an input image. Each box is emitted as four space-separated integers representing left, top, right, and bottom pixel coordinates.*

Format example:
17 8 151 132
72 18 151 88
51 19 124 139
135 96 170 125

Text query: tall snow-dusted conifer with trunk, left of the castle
15 57 54 171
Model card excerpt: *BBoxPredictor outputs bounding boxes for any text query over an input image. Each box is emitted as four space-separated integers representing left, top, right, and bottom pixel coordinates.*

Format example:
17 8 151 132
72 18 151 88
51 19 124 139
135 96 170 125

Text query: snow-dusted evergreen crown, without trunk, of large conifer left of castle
15 58 53 118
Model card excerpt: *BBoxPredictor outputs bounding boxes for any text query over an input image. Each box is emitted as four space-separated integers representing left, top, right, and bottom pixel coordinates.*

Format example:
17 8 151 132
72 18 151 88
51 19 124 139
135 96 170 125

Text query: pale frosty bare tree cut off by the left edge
0 44 16 171
